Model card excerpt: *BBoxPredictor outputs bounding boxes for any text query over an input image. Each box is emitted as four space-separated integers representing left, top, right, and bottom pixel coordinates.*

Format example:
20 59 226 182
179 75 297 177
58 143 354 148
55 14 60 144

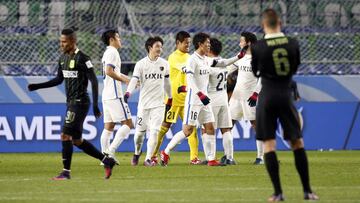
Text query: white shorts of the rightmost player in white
229 99 256 121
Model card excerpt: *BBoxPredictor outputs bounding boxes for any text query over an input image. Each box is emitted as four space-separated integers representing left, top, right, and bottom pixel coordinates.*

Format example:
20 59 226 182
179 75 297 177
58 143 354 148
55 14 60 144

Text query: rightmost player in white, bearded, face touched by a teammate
229 32 264 165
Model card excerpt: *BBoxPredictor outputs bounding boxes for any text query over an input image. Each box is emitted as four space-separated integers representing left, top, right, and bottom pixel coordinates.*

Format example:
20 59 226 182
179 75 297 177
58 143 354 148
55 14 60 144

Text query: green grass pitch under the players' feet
0 151 360 203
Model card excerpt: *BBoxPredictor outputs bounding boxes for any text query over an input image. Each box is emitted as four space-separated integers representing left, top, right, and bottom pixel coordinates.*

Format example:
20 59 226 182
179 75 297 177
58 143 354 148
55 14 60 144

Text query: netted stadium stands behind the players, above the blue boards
0 0 360 75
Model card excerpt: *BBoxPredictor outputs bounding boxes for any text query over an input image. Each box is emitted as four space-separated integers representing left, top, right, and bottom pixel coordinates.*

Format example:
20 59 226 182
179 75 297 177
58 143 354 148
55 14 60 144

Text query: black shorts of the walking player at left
62 103 90 139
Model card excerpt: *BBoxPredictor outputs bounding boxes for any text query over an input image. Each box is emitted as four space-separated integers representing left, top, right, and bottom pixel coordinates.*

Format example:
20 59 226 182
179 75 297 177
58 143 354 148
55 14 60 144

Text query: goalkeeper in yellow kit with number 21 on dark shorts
153 31 201 165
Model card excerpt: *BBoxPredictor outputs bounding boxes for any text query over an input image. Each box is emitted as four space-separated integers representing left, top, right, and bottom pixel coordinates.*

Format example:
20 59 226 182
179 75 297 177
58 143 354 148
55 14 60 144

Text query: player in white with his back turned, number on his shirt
203 38 236 165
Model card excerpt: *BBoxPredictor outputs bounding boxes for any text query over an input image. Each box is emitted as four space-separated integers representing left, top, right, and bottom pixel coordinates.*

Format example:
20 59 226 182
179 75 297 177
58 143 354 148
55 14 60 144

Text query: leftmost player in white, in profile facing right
100 30 133 163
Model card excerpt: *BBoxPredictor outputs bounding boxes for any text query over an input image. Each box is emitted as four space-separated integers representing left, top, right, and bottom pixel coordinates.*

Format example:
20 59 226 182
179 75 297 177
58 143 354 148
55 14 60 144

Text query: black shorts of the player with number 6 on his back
256 89 302 140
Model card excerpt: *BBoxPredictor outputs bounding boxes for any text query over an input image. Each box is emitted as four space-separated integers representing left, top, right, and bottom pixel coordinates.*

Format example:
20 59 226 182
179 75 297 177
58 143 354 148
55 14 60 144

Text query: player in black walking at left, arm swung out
28 29 115 180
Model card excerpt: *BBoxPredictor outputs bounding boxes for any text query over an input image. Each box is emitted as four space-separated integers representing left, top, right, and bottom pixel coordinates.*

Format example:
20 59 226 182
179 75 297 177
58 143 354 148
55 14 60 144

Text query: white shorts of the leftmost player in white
103 98 131 123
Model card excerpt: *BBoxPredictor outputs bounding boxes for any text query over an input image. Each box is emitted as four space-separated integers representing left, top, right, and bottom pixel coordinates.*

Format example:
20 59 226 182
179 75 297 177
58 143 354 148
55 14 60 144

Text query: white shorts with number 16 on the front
183 104 215 126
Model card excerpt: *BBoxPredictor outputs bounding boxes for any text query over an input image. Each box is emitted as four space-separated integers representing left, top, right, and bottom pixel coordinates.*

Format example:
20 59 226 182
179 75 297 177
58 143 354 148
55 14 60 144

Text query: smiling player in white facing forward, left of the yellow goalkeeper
125 37 171 166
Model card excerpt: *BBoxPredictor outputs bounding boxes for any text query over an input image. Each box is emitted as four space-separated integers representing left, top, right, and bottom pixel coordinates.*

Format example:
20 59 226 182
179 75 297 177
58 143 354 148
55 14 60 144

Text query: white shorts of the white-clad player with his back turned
212 105 232 129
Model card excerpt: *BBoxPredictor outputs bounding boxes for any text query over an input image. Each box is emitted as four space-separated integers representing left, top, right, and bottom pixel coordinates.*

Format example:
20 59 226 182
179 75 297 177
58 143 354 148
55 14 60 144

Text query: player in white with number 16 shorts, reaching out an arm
161 33 241 166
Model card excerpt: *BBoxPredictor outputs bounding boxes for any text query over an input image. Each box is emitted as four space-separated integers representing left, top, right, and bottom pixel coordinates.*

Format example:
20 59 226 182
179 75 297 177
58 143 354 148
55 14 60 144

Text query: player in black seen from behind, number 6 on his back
251 9 319 202
